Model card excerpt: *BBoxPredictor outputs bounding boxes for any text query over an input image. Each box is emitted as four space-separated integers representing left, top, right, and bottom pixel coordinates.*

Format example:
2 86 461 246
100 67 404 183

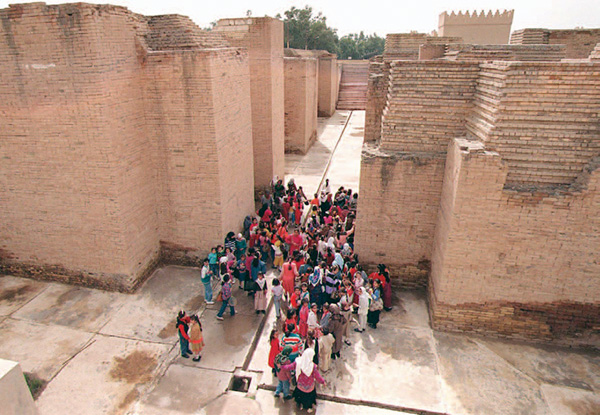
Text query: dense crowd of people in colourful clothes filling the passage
178 179 392 410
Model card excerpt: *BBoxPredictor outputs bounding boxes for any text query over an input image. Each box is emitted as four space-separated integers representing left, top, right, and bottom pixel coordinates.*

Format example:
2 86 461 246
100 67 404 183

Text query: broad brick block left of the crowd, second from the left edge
147 48 253 253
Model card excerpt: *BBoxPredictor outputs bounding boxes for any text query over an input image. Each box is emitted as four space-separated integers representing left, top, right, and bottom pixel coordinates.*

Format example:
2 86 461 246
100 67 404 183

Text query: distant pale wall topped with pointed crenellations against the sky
438 10 514 45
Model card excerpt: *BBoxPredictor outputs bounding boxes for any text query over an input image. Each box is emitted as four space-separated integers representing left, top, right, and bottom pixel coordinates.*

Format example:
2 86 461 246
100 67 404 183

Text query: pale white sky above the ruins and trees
0 0 600 36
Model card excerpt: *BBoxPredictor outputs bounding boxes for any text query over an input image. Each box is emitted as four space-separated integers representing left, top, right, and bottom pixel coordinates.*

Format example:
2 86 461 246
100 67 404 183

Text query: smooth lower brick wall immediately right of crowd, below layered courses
355 144 444 288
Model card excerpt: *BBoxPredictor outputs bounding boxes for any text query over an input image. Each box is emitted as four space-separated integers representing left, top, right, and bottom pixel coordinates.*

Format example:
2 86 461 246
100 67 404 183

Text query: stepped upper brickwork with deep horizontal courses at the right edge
467 62 600 186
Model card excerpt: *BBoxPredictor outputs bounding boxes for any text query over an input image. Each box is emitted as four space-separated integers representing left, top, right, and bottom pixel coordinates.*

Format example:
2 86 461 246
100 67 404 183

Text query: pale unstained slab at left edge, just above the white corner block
0 318 93 380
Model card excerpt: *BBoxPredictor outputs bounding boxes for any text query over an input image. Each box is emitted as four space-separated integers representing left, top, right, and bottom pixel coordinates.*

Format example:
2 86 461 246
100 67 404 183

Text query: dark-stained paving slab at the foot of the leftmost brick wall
13 284 127 332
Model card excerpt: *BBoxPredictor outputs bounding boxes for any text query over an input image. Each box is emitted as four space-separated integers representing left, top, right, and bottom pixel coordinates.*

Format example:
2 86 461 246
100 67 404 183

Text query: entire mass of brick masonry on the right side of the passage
356 26 600 344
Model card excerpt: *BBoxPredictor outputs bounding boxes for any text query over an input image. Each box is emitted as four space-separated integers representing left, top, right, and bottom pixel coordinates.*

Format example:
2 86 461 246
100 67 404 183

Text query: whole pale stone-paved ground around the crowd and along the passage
0 112 600 415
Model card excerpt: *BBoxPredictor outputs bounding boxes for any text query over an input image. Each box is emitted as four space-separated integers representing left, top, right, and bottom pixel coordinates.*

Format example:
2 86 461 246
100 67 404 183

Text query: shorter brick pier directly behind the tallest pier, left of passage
284 58 319 154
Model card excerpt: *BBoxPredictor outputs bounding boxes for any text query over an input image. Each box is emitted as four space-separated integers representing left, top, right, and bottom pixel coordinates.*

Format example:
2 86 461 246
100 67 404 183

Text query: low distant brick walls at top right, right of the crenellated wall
510 29 600 59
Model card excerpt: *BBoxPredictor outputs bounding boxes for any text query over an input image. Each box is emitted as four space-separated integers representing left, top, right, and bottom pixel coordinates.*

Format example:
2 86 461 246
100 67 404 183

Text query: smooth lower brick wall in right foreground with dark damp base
430 139 600 343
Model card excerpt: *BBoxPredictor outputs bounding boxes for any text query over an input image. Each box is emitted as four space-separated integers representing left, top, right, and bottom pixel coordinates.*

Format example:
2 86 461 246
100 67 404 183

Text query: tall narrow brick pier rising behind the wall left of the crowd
213 17 285 189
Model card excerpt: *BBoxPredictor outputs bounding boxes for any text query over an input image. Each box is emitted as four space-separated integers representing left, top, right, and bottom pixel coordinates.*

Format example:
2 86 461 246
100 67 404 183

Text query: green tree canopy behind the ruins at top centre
276 6 385 59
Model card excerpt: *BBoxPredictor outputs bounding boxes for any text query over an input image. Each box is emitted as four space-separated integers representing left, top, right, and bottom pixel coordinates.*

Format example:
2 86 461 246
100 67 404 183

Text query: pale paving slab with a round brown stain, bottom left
37 335 170 415
